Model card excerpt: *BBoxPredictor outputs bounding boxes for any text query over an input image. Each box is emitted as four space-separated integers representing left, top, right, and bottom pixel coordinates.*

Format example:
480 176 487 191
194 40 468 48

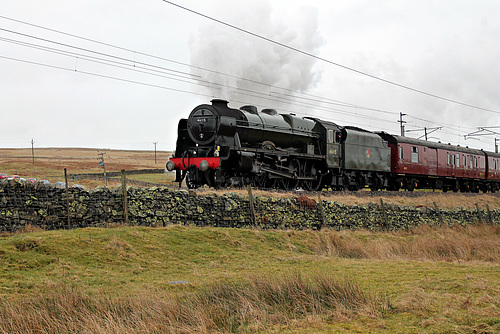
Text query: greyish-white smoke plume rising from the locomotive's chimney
190 0 323 106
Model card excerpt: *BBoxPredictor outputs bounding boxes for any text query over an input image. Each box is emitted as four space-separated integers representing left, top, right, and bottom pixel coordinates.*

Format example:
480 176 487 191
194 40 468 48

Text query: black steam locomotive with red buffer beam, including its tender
167 99 391 190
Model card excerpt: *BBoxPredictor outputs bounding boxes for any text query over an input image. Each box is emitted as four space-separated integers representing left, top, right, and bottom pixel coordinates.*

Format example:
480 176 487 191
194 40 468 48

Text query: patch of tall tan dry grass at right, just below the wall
312 224 500 264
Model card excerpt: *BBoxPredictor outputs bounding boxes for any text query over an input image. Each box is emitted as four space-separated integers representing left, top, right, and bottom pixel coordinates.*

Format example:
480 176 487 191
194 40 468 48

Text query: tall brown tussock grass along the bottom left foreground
0 273 387 333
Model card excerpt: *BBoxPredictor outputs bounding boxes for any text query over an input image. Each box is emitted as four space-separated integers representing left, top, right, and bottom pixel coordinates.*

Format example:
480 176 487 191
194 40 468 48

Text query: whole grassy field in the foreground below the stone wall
0 225 500 333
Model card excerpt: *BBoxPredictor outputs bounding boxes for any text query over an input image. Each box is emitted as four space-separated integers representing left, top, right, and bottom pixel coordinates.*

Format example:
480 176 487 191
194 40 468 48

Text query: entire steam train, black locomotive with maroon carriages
166 99 500 192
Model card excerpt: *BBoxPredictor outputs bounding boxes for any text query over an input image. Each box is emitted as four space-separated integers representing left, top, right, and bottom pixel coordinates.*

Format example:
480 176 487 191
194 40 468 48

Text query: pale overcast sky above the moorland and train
0 0 500 150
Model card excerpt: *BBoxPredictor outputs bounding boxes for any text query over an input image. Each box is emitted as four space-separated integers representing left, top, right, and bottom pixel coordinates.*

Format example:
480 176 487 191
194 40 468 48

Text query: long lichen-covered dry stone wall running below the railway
0 181 500 232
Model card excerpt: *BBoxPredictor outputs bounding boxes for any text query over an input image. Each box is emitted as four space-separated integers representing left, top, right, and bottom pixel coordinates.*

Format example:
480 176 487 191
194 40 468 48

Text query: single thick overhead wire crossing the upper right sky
162 0 500 114
